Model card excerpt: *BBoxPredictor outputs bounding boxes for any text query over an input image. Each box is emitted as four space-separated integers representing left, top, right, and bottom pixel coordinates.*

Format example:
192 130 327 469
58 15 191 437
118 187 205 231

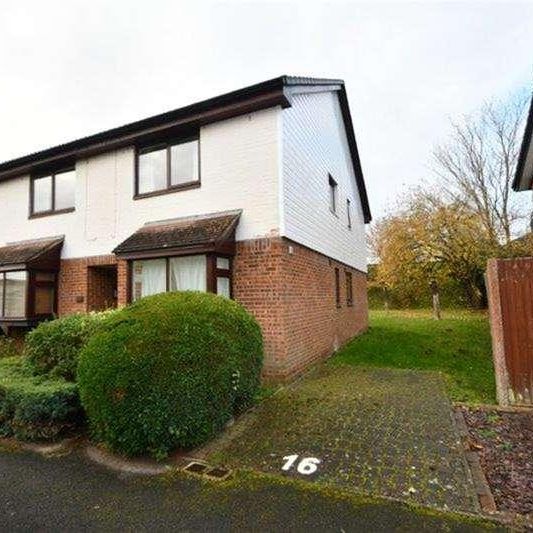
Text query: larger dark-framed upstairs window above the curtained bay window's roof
136 138 200 197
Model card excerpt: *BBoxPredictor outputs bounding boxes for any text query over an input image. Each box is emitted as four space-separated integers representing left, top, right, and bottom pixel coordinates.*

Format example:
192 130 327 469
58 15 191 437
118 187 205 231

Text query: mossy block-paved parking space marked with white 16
208 365 479 512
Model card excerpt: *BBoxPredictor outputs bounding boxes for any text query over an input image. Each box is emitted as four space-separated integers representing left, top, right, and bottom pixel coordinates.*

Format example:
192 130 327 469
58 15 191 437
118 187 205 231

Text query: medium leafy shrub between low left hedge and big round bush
24 311 114 381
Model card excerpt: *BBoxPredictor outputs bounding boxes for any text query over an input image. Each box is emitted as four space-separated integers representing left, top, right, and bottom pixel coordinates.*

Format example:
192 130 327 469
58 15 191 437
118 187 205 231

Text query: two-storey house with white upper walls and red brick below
0 76 371 379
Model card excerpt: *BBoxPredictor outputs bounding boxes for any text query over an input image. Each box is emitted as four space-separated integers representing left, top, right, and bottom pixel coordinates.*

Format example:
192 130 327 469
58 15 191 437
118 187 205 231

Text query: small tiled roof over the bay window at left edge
0 235 64 270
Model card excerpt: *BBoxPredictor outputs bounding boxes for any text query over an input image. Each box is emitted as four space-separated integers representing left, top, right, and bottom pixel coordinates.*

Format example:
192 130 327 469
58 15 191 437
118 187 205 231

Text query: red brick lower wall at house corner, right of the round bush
233 238 368 380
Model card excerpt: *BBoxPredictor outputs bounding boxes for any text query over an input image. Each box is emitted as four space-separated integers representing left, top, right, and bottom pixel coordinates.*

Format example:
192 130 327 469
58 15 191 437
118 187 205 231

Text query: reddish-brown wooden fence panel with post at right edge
487 257 533 405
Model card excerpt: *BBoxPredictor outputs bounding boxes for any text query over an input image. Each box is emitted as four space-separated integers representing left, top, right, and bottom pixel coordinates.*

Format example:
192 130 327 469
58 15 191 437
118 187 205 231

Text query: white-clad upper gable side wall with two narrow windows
282 91 367 272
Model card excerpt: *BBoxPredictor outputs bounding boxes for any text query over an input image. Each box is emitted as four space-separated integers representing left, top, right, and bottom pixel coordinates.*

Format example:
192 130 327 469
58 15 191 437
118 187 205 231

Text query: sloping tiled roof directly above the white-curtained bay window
113 210 242 259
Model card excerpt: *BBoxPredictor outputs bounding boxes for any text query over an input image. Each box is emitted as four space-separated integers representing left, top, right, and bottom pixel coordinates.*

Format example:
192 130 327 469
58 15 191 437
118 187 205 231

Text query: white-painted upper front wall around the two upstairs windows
0 107 281 258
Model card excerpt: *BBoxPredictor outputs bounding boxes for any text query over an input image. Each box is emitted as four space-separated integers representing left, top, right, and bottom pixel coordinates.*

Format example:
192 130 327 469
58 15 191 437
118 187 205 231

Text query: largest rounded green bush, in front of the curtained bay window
78 292 263 457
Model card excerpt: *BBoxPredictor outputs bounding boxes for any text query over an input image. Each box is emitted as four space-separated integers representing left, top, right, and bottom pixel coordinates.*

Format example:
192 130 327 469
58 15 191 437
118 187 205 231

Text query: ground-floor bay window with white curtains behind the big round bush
131 254 231 301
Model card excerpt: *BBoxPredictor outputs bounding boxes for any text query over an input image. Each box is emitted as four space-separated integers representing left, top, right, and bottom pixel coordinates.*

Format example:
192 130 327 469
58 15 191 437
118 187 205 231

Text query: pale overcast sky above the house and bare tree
0 0 533 218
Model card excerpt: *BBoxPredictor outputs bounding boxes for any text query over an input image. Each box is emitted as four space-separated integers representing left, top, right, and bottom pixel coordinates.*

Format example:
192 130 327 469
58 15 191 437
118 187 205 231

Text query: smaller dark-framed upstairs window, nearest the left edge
30 169 76 216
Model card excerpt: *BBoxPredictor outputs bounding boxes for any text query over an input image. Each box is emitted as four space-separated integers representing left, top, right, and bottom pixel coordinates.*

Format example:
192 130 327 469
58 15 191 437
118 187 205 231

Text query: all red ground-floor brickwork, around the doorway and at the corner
58 237 368 381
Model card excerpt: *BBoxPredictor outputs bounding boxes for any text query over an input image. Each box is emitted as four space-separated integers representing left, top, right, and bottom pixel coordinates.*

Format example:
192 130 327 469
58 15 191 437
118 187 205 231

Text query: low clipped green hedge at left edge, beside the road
0 357 83 441
